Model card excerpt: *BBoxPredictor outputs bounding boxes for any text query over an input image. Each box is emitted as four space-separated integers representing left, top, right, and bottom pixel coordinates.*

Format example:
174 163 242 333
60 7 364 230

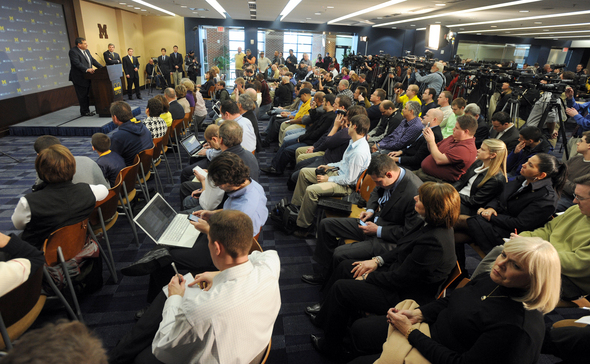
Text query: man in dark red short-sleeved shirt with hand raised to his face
415 115 477 183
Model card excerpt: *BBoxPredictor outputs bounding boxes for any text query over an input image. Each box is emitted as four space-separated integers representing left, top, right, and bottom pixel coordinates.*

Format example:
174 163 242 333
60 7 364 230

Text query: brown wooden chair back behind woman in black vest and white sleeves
43 219 88 267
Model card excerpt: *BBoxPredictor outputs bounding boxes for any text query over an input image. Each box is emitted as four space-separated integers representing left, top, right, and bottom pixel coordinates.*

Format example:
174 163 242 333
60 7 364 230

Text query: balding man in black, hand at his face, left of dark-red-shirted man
389 109 443 171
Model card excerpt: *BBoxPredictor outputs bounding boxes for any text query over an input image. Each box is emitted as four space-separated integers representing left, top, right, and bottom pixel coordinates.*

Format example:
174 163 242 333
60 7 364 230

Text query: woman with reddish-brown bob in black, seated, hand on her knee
305 182 461 355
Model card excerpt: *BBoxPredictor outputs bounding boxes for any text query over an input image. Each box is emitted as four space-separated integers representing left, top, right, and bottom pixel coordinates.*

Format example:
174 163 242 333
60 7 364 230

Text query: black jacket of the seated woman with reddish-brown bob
367 224 457 304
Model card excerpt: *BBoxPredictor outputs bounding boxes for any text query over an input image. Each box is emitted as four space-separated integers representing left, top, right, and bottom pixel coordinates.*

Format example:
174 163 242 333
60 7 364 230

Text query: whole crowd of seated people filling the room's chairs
6 52 590 363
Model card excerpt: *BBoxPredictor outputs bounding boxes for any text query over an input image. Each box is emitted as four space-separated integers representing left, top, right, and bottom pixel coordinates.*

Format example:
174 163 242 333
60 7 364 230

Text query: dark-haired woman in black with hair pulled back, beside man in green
467 153 567 252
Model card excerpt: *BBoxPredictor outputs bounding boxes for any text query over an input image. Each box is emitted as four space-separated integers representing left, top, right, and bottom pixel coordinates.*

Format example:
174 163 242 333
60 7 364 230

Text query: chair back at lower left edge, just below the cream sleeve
0 267 47 350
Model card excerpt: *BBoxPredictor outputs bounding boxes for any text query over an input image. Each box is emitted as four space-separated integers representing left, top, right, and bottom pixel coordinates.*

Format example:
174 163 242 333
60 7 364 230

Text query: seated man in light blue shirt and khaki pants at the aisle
291 115 371 238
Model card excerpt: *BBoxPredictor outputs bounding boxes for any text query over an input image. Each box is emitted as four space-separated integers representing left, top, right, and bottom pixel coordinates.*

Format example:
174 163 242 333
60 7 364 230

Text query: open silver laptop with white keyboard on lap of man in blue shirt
134 193 200 248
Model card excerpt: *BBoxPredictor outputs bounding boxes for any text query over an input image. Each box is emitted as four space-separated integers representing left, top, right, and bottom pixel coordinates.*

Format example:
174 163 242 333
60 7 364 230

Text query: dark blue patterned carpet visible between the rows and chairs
0 87 586 364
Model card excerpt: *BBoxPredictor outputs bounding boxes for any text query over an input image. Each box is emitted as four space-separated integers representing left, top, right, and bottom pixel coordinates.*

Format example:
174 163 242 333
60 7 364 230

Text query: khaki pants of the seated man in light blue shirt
291 168 352 228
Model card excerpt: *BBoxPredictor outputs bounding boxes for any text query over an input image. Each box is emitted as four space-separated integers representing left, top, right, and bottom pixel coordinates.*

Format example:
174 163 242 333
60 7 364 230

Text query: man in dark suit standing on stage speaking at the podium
68 37 103 116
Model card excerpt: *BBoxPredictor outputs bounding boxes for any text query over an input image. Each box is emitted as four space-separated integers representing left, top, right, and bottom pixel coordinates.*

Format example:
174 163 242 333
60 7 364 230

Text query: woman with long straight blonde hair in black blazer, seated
454 139 508 216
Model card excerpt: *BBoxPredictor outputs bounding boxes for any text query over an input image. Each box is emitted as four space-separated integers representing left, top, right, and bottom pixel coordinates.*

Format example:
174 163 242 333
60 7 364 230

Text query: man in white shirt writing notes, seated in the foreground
109 210 281 364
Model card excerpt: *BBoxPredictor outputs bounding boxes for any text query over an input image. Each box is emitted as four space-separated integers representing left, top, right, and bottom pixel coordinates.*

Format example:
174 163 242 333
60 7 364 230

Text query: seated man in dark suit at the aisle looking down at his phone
301 154 423 284
